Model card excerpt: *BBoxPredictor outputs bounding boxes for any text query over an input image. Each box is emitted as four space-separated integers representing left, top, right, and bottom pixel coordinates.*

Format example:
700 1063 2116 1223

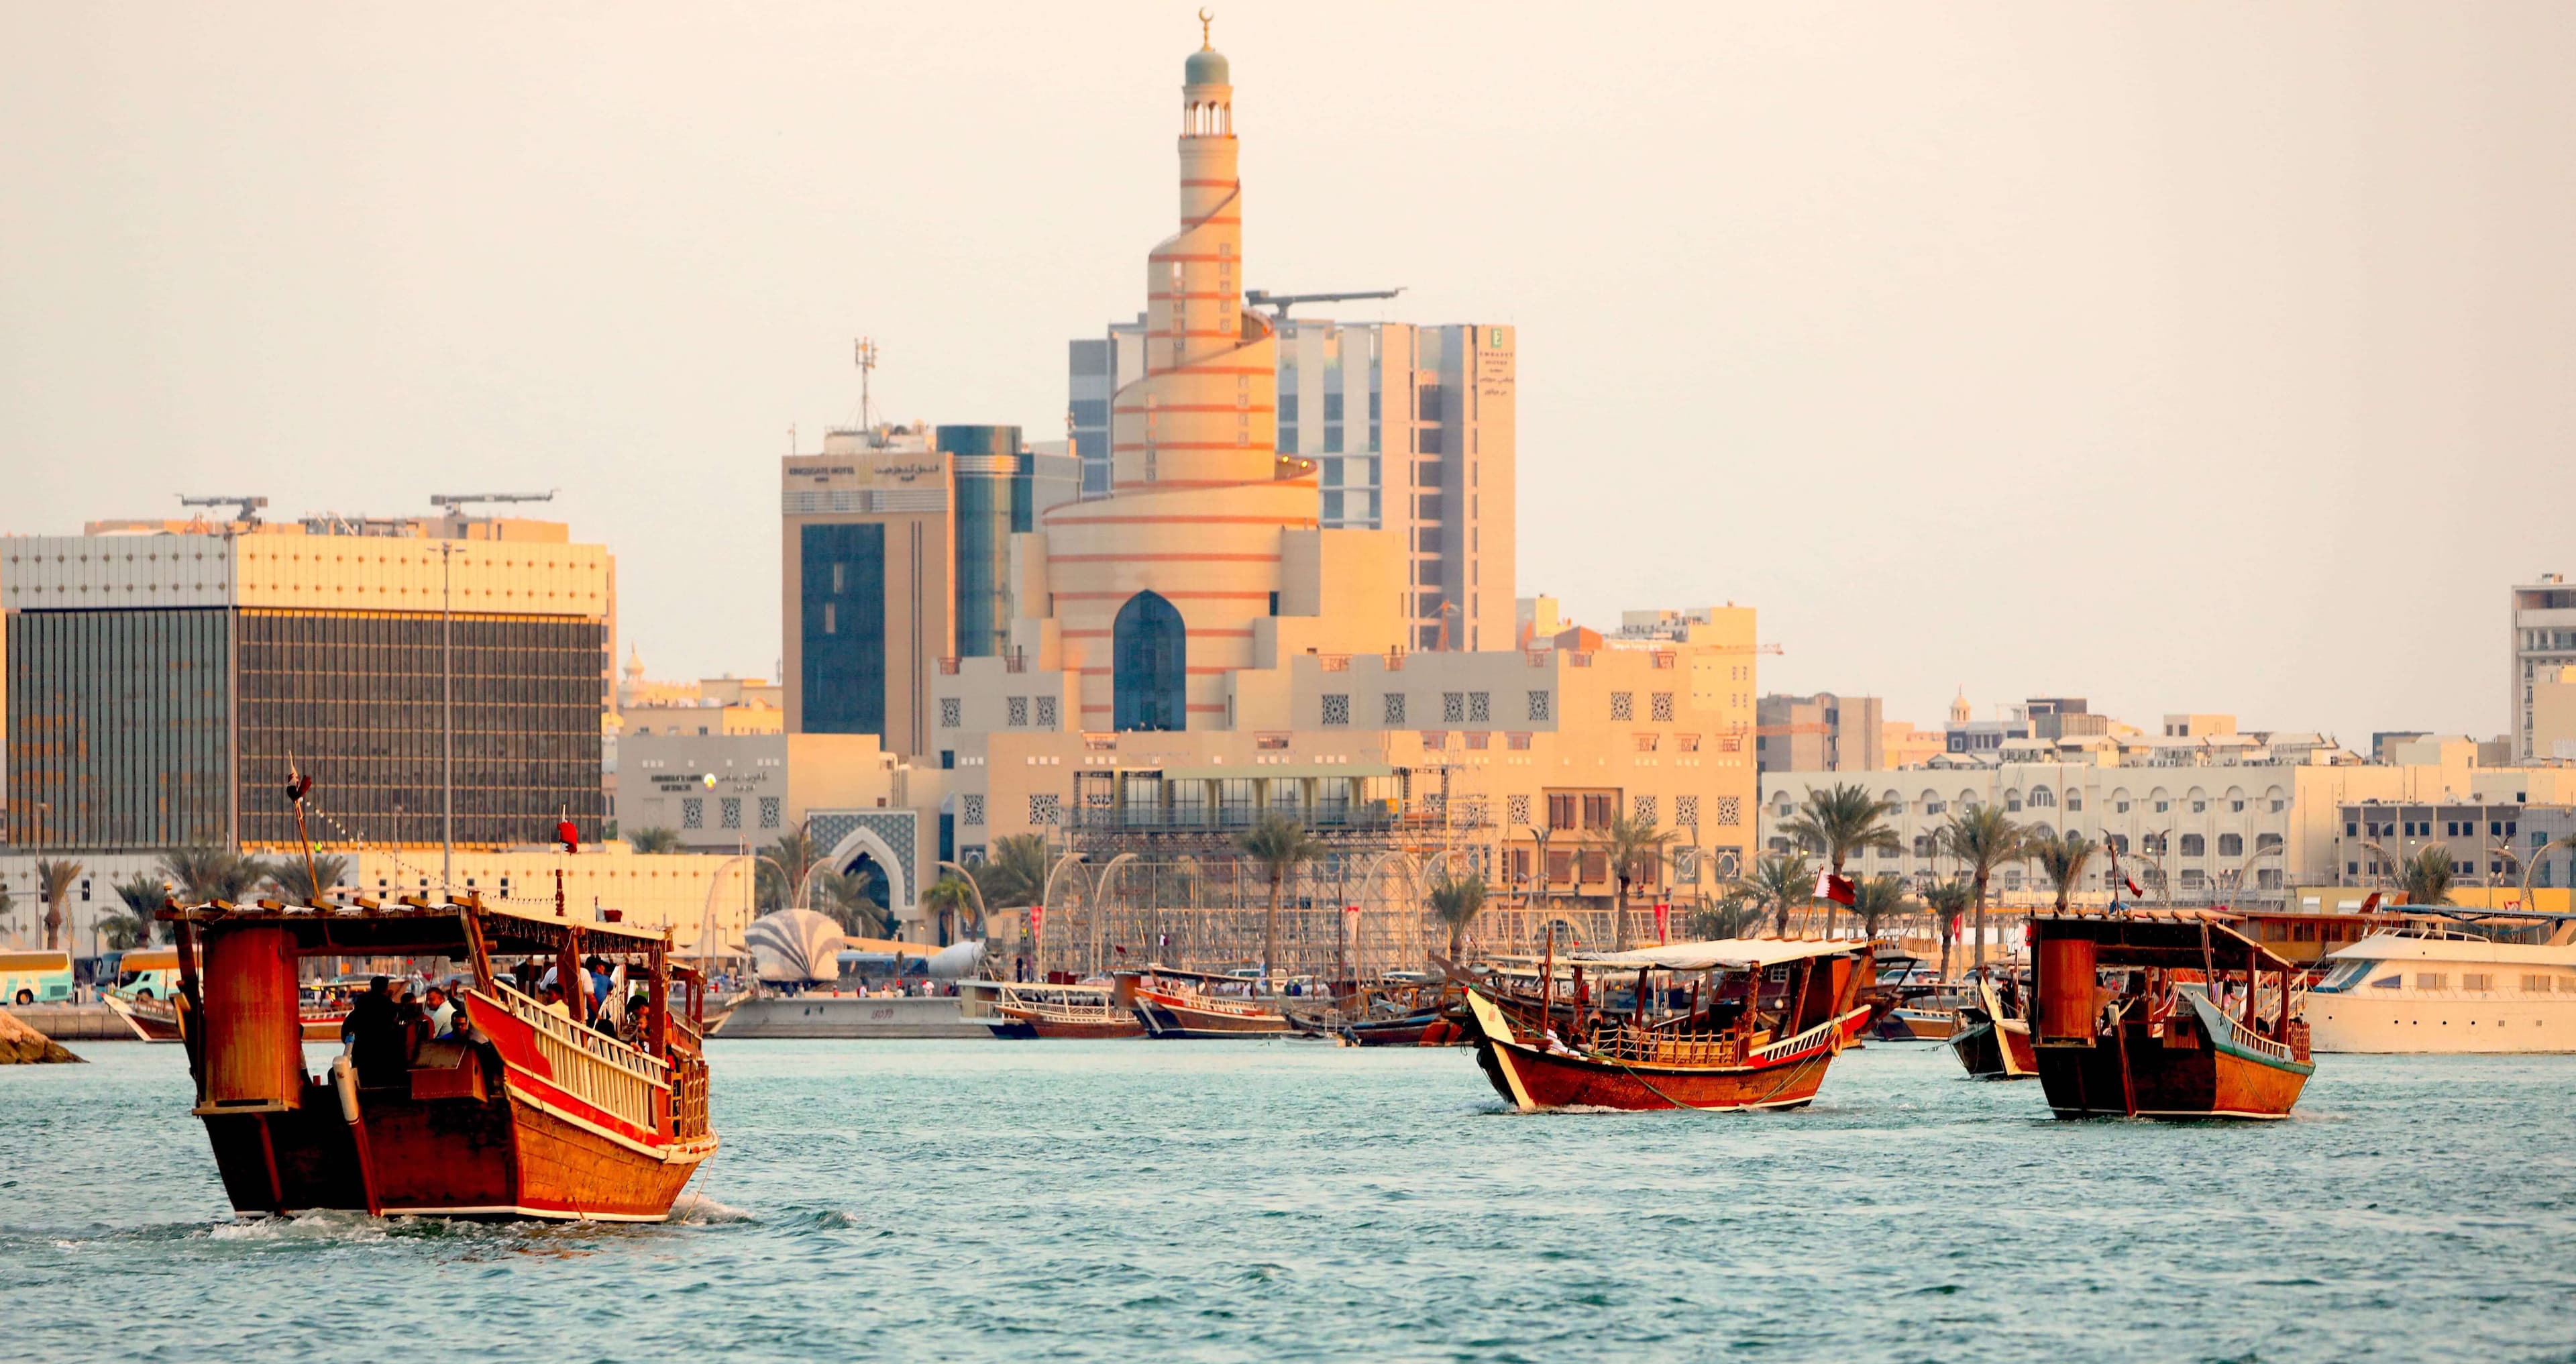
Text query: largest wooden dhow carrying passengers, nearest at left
160 897 716 1222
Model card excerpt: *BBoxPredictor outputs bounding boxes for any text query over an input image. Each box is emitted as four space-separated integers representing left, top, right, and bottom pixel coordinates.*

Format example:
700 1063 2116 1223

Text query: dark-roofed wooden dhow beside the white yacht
2030 908 2316 1119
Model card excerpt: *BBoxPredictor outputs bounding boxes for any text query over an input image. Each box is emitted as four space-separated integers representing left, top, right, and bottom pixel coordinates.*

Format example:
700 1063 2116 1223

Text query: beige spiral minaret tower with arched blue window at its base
1046 23 1319 730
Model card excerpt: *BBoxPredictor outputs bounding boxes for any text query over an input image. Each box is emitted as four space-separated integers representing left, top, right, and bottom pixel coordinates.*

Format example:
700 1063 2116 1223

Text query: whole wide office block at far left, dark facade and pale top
0 516 616 851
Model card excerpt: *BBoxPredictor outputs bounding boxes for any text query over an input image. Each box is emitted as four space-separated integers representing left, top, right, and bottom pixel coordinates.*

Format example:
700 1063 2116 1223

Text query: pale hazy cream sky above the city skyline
0 0 2576 745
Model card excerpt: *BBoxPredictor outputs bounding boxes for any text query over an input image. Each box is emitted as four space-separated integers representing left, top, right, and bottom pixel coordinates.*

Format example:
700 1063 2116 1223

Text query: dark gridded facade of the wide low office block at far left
8 609 608 851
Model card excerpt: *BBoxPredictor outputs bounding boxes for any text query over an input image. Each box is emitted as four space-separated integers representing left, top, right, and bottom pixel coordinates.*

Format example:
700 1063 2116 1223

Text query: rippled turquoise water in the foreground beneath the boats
0 1042 2576 1361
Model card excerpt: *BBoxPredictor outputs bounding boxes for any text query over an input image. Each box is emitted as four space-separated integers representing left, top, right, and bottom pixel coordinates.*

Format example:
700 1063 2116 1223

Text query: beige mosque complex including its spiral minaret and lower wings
896 23 1757 959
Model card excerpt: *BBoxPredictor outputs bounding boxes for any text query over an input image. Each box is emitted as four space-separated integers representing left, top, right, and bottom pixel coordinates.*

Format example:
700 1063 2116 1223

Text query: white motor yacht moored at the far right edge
2308 929 2576 1052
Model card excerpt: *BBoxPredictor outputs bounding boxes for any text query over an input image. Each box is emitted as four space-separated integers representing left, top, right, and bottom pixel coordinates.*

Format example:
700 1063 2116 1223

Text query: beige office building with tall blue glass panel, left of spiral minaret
781 425 1074 755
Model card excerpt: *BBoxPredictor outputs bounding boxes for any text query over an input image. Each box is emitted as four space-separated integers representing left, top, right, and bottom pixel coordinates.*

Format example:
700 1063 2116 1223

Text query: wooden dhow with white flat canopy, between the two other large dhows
1466 939 1870 1114
